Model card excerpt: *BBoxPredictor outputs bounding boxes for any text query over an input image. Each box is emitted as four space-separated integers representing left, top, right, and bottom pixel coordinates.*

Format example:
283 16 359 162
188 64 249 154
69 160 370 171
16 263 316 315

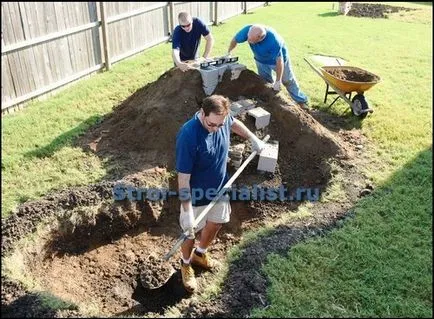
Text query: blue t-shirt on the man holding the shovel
176 112 234 206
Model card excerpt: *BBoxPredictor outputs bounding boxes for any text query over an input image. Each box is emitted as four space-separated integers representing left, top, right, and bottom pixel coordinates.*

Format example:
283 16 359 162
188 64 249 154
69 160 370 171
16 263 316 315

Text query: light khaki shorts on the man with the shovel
179 195 231 232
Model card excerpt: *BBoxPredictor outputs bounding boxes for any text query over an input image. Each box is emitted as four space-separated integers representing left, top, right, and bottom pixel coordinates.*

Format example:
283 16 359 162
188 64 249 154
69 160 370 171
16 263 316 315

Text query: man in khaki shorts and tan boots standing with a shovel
176 95 265 292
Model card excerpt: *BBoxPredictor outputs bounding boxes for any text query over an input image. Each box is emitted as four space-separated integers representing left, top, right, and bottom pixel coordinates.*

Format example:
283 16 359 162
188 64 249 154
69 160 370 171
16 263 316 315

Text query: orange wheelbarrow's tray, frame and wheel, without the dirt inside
304 58 381 118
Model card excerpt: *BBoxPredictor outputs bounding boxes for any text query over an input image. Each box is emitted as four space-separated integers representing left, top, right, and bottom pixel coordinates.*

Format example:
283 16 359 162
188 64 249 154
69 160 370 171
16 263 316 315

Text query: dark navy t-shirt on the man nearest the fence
172 18 210 61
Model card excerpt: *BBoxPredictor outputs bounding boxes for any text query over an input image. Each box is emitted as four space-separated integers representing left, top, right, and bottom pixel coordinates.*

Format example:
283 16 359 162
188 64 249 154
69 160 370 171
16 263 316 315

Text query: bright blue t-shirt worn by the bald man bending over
235 25 288 65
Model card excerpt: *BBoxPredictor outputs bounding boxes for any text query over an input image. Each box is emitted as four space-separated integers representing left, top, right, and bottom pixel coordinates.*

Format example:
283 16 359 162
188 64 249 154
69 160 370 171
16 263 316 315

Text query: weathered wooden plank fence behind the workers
1 2 267 112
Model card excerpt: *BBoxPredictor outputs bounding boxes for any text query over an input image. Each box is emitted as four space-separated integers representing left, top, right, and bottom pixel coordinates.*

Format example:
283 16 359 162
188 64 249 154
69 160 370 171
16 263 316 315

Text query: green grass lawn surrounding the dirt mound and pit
2 2 432 317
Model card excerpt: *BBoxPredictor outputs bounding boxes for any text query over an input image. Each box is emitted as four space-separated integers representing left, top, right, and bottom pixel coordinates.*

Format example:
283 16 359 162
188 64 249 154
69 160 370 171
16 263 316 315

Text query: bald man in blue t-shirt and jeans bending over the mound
228 24 308 107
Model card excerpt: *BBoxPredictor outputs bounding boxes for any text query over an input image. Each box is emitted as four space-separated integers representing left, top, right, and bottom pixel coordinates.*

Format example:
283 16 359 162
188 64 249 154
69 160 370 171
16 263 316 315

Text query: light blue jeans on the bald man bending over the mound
255 57 308 103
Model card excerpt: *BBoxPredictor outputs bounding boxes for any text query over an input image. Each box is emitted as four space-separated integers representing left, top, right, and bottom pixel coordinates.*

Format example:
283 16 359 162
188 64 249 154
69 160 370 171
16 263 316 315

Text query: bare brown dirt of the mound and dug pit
1 69 372 317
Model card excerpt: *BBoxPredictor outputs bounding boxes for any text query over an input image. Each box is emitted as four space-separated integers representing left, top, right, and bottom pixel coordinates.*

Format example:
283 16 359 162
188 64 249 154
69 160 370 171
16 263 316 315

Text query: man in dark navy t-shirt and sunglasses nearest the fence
172 12 214 72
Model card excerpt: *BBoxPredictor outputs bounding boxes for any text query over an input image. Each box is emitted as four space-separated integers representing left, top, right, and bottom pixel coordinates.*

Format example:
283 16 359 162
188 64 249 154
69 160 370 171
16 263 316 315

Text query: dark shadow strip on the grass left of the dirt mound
24 115 101 159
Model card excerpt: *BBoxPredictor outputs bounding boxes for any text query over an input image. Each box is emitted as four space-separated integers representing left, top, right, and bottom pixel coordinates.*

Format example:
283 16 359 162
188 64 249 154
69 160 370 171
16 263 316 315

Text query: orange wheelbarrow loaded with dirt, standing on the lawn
304 56 381 118
